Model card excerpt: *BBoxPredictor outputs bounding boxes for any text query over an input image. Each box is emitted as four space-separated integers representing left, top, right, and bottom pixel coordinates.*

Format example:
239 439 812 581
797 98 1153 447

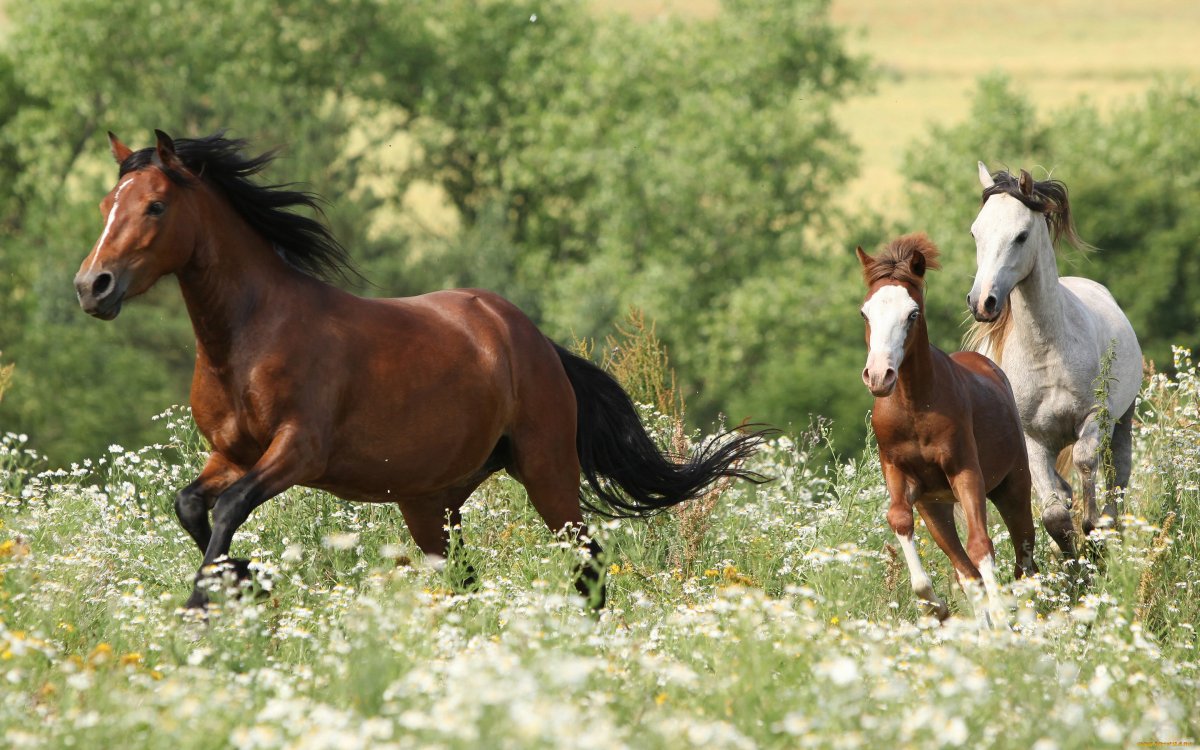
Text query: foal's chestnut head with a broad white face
857 233 941 397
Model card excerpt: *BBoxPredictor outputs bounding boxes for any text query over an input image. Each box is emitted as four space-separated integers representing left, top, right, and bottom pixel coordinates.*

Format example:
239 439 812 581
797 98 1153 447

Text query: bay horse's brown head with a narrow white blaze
74 131 196 320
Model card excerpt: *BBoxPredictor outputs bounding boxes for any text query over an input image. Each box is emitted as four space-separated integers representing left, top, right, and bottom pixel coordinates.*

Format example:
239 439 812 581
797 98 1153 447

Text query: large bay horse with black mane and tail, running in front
76 131 761 607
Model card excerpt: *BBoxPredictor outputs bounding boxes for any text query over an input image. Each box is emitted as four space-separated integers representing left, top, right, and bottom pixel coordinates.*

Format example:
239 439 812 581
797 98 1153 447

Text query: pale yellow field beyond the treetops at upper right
609 0 1200 212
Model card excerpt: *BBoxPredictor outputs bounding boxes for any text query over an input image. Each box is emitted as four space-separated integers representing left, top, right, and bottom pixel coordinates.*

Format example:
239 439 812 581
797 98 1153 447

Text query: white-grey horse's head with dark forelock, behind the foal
967 162 1078 323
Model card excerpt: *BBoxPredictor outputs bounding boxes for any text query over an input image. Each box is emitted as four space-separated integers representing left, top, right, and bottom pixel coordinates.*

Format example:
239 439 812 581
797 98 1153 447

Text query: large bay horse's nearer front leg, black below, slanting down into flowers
187 427 326 607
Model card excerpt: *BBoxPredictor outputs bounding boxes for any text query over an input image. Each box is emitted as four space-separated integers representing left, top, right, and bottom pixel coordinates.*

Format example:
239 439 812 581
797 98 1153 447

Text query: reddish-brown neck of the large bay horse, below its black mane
178 197 313 367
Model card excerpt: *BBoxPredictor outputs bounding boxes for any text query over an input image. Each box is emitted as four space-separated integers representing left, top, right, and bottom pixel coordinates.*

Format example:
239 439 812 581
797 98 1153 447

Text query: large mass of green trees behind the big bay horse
0 0 865 460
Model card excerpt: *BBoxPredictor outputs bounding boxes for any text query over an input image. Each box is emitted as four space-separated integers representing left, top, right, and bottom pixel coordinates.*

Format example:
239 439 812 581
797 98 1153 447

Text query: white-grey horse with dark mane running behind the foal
967 162 1142 557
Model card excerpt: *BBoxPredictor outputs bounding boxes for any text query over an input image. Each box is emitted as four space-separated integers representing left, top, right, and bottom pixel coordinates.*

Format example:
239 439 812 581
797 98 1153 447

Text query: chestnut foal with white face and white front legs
857 234 1037 623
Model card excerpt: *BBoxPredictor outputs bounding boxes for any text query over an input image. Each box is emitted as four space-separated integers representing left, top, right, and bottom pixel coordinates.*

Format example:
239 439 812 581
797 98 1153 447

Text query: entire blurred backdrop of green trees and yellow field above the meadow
0 0 1200 462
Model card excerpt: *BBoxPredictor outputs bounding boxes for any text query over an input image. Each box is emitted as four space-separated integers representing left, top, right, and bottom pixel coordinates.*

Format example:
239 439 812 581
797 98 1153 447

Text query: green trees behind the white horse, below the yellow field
905 77 1200 366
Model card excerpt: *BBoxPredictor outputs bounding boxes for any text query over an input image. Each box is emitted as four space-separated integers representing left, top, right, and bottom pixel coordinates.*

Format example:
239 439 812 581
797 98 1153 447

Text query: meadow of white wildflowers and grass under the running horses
0 350 1200 750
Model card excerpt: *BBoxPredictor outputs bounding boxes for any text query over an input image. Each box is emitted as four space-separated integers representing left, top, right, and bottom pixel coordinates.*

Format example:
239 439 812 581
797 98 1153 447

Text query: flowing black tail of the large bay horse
554 344 767 517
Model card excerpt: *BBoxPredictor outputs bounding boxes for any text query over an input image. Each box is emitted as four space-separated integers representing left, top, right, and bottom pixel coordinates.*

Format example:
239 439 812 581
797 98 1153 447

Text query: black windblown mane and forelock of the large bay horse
120 132 361 281
